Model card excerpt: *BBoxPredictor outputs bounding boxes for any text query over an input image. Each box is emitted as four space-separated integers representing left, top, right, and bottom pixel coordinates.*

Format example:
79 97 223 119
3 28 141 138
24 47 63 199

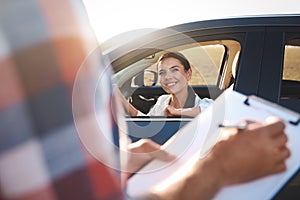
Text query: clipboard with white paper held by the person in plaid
126 89 300 200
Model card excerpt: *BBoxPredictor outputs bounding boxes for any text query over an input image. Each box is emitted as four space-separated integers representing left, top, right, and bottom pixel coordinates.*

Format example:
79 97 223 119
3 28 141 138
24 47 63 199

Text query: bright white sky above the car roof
83 0 300 43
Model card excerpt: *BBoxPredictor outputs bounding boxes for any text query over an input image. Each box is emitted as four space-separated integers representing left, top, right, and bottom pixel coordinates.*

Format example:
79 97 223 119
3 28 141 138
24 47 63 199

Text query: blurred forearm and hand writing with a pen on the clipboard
139 118 290 200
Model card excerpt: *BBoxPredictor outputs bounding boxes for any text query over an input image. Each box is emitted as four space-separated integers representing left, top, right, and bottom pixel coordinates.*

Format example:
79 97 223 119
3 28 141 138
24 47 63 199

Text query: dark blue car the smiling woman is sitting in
103 14 300 199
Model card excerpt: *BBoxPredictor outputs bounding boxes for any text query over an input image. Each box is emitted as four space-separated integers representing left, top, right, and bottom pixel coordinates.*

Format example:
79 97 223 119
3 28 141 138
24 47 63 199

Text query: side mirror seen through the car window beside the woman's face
132 69 158 87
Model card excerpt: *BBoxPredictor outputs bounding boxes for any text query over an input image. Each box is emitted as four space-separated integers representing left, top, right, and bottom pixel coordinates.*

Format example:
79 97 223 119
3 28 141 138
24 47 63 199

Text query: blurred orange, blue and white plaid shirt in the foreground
0 0 123 200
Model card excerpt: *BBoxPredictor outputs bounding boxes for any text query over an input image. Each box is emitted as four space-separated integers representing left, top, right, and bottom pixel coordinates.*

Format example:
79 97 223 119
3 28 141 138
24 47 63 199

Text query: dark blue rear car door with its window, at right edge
258 26 300 112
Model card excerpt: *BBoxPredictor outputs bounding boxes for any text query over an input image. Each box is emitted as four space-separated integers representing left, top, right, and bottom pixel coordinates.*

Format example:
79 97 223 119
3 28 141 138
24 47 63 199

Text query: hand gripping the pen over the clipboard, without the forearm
209 118 290 185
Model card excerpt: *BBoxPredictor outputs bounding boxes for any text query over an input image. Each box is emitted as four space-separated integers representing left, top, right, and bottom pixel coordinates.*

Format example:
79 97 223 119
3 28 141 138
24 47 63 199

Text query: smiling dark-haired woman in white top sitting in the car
118 52 213 117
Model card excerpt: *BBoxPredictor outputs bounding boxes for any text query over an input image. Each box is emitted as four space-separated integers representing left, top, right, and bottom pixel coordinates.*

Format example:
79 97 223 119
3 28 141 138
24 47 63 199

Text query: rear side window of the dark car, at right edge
281 39 300 99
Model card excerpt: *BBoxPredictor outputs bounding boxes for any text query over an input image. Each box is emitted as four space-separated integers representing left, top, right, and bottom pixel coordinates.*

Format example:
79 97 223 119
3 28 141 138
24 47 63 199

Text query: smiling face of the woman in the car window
158 58 192 94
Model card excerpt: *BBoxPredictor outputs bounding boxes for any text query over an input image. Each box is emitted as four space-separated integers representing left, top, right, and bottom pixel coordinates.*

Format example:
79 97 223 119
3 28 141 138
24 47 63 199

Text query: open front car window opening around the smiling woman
114 40 241 113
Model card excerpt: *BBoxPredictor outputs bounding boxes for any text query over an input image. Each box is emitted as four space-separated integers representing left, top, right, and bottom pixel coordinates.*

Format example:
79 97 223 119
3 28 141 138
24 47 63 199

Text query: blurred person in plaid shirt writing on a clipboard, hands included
0 0 289 200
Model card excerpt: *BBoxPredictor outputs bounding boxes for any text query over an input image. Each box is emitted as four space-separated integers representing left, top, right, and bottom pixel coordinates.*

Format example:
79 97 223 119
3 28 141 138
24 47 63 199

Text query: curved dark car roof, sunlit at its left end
104 14 300 68
